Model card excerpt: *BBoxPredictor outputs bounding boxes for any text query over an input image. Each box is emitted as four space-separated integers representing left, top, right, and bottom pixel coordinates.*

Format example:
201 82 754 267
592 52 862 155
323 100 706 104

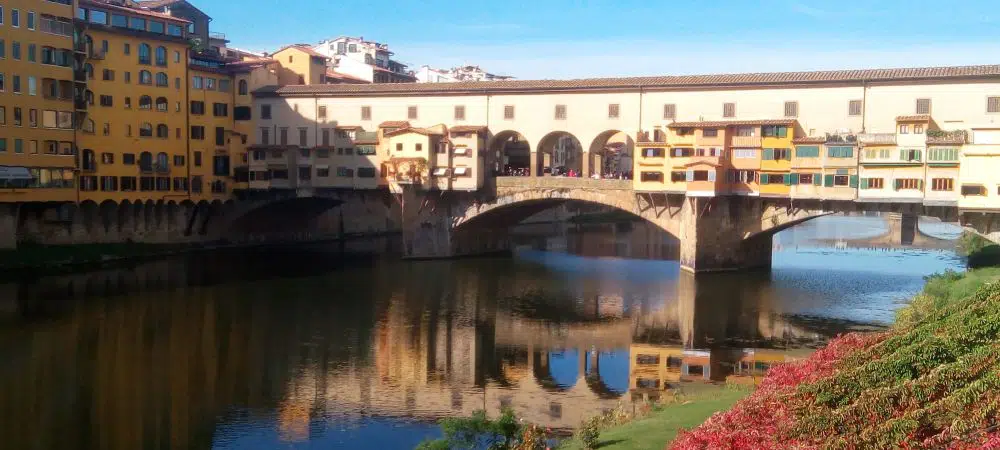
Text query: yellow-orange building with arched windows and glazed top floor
77 0 192 203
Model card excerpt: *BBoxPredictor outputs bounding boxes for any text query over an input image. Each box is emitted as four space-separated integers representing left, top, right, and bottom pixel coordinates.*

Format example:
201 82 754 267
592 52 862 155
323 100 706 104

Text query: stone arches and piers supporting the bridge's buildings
396 177 958 272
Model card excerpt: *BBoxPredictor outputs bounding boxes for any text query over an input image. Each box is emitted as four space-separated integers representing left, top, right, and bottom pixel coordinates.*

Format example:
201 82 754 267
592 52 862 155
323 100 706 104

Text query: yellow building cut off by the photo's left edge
0 0 78 203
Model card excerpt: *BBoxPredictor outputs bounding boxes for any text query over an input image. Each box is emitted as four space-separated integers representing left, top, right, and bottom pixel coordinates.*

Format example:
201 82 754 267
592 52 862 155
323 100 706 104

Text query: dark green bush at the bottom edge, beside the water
417 408 545 450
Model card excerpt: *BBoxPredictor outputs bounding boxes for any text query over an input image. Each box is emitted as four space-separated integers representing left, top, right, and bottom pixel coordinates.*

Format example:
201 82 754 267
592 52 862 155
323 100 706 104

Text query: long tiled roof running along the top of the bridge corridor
257 65 1000 96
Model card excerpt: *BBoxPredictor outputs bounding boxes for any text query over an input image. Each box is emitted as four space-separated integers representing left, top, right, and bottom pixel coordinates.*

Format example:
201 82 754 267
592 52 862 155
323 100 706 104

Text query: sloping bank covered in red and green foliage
672 268 1000 450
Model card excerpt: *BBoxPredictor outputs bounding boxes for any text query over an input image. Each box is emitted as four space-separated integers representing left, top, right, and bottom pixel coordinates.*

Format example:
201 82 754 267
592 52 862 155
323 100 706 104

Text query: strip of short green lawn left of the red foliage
559 386 750 450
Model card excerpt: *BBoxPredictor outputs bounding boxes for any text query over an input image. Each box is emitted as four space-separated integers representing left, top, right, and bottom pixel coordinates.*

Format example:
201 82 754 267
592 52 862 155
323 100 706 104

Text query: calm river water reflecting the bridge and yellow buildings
0 217 963 450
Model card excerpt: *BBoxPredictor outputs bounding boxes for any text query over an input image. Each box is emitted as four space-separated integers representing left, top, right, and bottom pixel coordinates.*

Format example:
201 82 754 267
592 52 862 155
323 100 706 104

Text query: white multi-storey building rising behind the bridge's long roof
312 36 416 83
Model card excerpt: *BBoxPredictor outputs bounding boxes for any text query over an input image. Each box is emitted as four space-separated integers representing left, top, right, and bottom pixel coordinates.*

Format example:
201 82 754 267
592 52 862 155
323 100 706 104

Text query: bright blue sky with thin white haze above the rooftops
197 0 1000 79
